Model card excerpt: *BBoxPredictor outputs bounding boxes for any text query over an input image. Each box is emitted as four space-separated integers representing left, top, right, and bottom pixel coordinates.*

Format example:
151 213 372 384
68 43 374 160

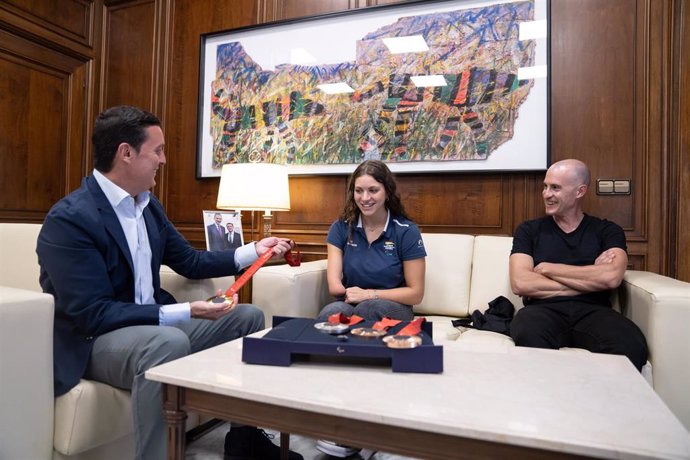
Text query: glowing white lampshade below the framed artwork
216 163 290 211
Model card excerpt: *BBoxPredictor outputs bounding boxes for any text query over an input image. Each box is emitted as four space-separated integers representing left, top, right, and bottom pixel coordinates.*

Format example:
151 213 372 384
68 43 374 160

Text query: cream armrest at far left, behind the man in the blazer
0 286 55 459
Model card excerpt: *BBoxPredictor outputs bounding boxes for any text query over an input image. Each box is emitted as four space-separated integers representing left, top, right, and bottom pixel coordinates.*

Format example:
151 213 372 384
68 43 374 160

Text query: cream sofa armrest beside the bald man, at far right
620 270 690 429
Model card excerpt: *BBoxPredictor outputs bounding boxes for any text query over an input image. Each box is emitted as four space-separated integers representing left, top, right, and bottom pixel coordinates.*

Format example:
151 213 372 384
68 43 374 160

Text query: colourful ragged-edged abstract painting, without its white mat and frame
196 1 536 176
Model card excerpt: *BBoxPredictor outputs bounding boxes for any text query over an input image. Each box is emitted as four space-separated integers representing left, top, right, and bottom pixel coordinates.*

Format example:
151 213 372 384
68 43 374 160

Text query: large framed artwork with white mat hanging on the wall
197 0 550 177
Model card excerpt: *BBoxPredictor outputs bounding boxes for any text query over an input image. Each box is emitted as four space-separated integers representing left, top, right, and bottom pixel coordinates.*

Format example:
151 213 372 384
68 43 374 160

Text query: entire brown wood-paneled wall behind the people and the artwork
0 0 690 280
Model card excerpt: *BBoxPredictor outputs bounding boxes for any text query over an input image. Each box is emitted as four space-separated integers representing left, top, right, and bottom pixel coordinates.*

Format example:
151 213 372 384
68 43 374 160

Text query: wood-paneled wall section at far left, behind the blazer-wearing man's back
0 0 100 222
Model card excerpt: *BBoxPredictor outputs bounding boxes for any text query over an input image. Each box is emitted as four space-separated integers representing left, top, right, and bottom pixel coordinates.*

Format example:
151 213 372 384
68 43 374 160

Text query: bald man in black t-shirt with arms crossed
510 160 647 370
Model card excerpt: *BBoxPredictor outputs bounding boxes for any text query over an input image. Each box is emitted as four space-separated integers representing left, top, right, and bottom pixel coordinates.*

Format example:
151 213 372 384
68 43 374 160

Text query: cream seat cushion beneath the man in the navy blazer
53 379 132 455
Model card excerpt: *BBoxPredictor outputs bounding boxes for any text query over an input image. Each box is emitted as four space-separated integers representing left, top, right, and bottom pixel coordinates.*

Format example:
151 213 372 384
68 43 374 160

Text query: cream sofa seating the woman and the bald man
252 234 690 429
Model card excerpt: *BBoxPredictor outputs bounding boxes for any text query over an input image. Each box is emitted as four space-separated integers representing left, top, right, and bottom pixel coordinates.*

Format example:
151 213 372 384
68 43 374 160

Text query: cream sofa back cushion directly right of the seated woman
414 233 474 317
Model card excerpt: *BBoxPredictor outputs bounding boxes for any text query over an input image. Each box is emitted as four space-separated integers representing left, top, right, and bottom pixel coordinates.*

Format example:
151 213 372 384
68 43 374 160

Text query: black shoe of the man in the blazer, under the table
225 426 303 460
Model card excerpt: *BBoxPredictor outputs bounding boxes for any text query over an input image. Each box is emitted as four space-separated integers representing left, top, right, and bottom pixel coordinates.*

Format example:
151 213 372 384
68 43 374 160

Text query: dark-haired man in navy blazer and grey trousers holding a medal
36 106 301 460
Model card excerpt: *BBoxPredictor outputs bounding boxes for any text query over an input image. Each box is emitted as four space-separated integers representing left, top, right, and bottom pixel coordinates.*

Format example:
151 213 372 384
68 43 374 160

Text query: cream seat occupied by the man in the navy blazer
0 223 234 460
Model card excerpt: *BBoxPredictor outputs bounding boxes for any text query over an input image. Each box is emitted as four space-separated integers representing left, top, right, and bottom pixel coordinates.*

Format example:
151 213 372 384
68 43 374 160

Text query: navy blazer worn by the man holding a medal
36 176 242 396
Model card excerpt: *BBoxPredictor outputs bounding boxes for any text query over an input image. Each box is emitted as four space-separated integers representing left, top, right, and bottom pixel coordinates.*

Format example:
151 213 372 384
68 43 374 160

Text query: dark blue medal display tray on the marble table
242 316 443 373
